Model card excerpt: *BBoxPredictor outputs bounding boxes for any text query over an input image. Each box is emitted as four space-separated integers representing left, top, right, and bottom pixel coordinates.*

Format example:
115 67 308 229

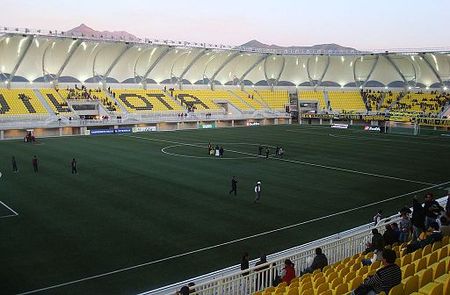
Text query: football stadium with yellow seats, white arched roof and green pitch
0 9 450 295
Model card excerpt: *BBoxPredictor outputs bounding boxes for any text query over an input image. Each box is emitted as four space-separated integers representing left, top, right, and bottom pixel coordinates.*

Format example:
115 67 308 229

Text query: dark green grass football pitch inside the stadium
0 125 450 294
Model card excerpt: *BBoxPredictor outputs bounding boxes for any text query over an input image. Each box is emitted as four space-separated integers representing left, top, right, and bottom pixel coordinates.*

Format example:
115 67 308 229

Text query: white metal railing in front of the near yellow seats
139 197 447 295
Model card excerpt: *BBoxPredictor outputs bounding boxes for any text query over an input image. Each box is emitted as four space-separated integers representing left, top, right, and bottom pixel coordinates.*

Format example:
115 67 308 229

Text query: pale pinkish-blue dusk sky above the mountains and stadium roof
0 0 450 49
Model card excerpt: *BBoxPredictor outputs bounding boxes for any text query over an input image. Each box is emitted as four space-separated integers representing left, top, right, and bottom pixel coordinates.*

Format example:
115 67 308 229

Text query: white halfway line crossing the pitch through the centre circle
124 135 434 185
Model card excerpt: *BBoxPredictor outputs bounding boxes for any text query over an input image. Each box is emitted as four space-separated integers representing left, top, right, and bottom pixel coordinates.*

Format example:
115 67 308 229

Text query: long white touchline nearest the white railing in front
17 181 450 295
